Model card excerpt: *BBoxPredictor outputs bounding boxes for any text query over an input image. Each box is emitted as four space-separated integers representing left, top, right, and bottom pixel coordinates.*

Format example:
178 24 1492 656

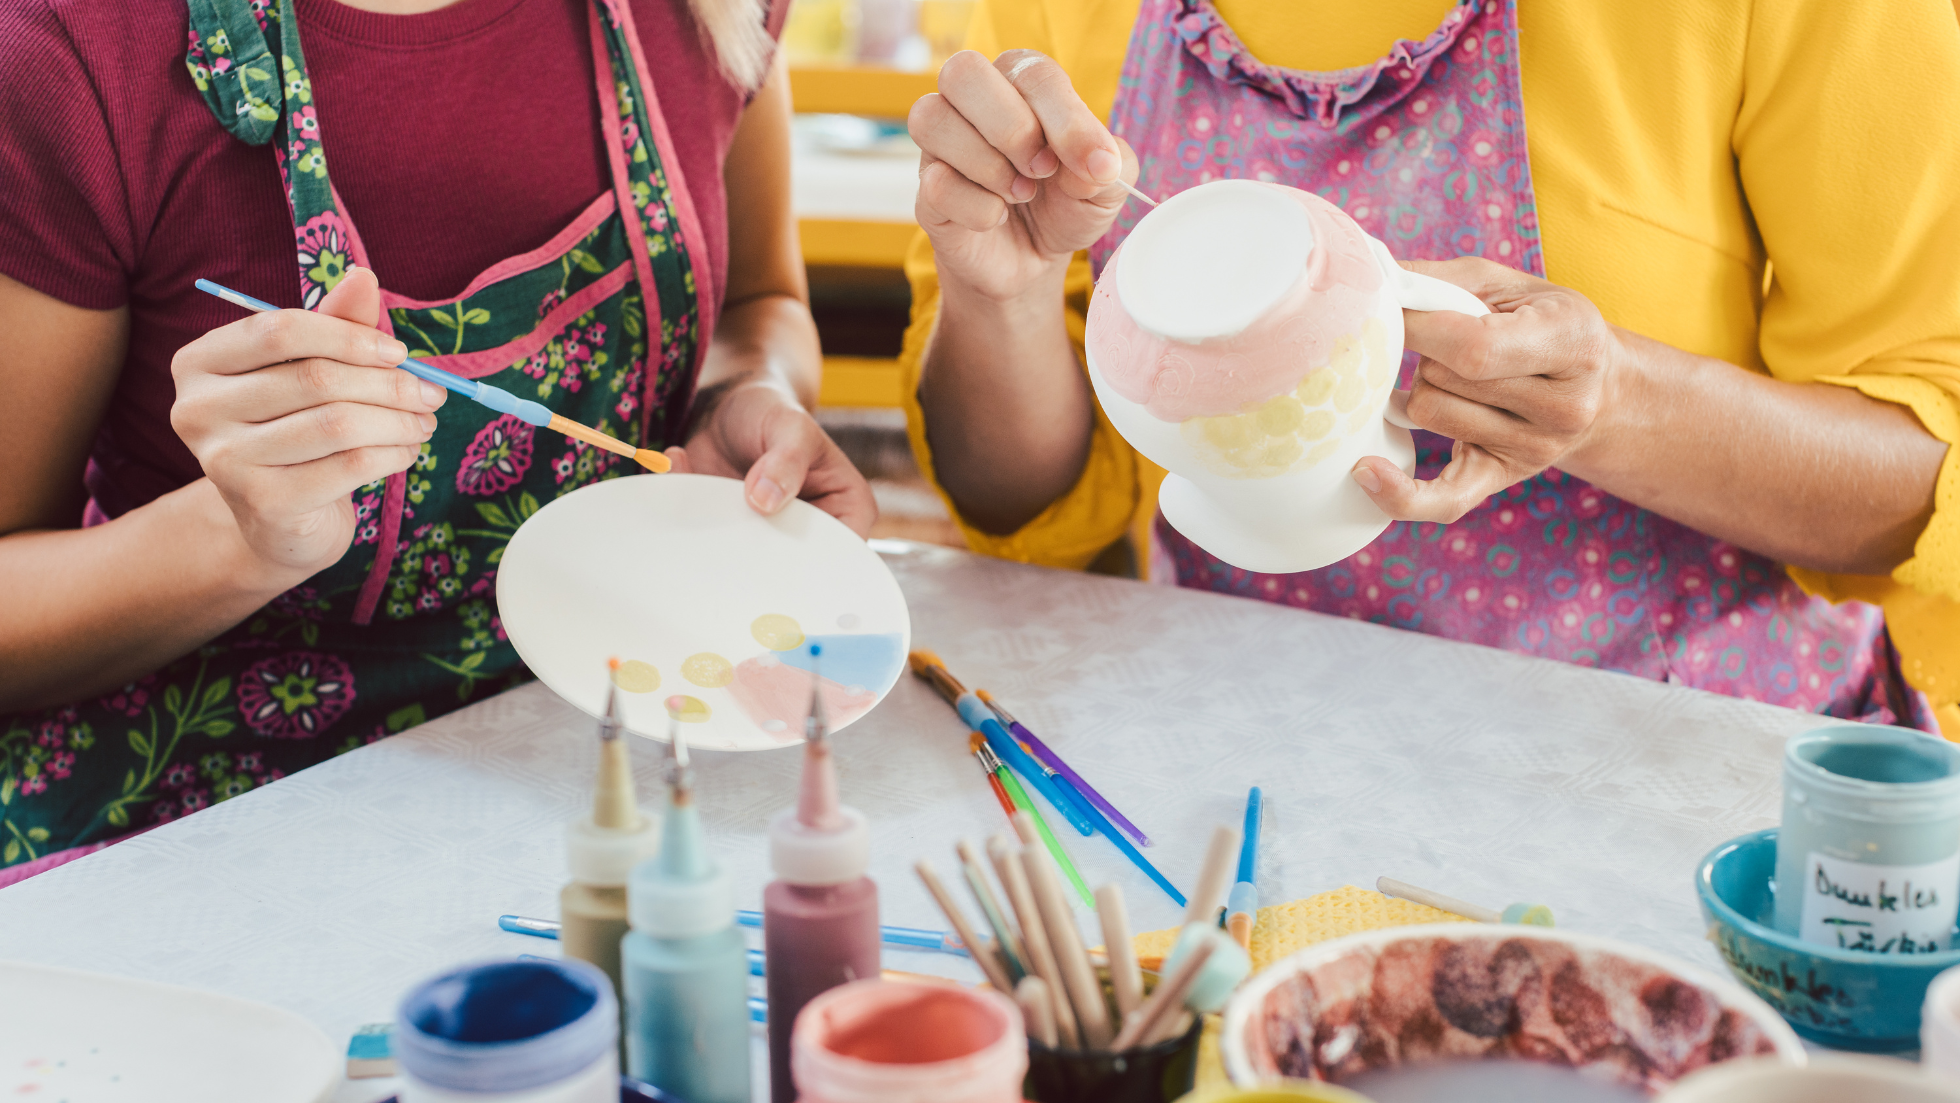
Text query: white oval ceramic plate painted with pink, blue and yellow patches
496 474 911 750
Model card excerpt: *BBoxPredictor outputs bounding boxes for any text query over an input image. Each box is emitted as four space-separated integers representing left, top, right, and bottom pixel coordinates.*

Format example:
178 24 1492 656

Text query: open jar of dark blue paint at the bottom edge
394 960 619 1103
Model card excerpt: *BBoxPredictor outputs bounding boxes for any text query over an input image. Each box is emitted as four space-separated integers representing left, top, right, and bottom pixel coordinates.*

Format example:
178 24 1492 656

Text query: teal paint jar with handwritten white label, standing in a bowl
1776 723 1960 954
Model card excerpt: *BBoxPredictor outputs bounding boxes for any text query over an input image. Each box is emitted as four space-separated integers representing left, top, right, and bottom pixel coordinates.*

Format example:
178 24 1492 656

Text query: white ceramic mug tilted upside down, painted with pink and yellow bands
1086 180 1490 574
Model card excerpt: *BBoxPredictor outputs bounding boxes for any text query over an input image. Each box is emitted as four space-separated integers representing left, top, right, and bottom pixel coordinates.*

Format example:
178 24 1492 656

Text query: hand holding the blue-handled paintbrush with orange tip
171 268 447 582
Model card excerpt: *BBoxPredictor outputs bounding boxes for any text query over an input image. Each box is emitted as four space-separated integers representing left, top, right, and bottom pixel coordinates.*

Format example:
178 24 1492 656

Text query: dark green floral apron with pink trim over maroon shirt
0 0 713 884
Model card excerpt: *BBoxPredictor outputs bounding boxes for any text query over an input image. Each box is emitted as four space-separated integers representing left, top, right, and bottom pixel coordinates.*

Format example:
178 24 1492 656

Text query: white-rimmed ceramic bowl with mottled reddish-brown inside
1221 923 1805 1095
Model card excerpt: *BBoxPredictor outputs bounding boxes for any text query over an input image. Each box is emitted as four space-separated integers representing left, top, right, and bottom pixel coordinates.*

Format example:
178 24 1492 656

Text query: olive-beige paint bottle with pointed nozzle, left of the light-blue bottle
559 658 661 1018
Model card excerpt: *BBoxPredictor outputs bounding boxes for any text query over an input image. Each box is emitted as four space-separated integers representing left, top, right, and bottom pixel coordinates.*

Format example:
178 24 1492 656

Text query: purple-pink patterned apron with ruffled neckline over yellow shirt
1092 0 1938 731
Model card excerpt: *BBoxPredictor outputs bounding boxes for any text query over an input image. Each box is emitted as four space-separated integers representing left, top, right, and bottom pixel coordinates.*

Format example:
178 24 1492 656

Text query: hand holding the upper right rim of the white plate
666 382 878 537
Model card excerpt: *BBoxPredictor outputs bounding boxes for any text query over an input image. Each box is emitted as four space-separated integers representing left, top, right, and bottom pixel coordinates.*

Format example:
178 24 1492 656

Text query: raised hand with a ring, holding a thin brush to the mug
907 49 1137 298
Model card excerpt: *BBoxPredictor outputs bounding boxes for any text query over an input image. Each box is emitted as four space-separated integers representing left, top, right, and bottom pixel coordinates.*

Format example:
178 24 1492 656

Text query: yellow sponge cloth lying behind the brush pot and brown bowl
1133 886 1474 1091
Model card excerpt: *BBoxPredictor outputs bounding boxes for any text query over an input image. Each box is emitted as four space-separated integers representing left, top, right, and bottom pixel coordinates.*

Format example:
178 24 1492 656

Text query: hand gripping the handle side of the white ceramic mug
1352 257 1629 525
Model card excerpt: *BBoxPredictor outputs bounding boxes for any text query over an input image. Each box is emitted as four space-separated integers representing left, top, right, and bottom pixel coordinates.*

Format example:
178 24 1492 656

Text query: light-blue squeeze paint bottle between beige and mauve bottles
619 697 749 1103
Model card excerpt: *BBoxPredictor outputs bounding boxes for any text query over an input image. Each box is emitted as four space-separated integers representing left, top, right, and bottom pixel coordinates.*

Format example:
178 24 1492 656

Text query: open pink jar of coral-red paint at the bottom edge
790 980 1027 1103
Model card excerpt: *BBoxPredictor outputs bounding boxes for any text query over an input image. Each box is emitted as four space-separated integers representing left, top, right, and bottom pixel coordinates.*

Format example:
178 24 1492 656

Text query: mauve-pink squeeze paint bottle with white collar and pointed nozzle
762 645 880 1103
